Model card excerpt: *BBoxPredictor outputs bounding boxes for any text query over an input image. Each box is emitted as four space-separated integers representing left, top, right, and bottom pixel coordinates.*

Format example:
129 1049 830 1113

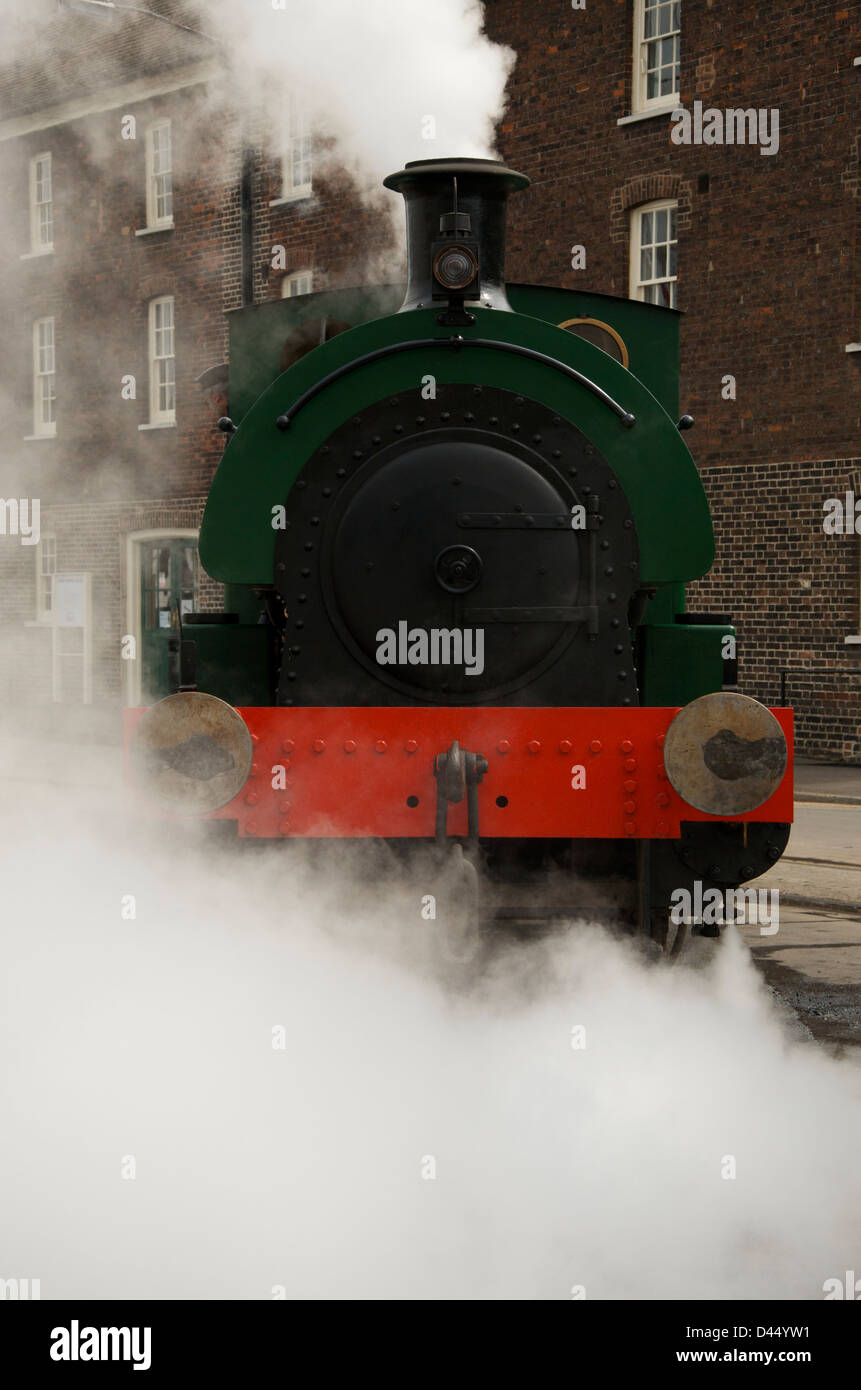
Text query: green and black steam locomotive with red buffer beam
128 158 793 951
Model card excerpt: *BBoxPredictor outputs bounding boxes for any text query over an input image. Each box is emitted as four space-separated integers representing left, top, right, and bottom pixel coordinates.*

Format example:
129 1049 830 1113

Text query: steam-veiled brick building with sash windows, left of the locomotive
0 0 388 708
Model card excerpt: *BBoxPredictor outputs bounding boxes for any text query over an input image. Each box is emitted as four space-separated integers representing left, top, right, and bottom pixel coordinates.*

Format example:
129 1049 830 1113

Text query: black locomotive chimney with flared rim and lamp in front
383 160 529 322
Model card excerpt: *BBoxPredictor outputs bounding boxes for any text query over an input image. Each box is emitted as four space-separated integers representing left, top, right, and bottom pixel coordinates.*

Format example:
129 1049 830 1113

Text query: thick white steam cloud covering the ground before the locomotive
0 783 861 1300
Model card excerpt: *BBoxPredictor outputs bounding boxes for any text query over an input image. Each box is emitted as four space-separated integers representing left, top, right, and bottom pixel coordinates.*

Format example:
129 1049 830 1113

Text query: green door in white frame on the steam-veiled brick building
140 538 198 705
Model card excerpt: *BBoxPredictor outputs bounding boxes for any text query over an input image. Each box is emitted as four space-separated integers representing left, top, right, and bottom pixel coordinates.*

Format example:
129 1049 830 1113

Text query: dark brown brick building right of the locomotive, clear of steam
487 0 861 763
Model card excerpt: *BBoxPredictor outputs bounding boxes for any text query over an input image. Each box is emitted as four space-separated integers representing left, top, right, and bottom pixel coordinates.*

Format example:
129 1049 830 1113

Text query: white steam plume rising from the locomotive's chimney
211 0 515 190
